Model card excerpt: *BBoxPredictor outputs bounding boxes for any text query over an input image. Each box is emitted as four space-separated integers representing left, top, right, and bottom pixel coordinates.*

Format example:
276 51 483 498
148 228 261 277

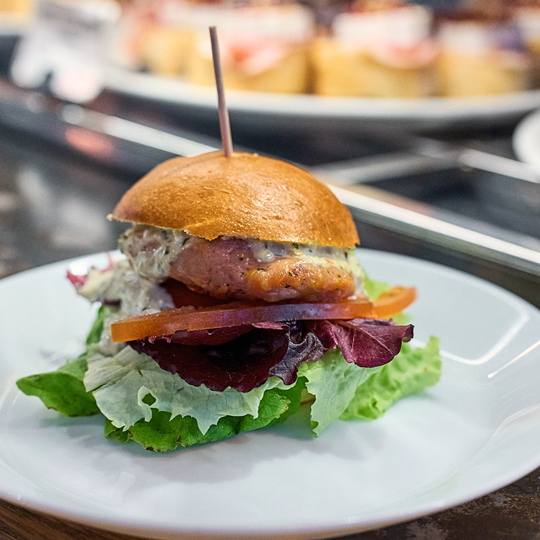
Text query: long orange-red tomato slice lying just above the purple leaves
111 287 416 343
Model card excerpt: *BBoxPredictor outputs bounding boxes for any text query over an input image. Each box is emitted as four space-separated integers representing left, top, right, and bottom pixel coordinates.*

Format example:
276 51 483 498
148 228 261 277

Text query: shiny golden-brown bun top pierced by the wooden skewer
109 152 360 248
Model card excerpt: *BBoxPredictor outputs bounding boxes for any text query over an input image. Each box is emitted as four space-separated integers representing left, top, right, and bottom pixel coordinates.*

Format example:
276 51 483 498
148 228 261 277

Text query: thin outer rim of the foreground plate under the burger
0 248 540 539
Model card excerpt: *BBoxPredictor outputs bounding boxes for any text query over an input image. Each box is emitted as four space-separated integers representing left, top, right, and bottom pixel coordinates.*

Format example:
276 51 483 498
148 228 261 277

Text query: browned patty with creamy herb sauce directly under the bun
120 221 363 302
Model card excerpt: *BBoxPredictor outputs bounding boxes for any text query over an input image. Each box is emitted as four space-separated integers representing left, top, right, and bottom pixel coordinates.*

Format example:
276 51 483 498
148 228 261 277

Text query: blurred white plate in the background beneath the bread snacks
106 64 540 129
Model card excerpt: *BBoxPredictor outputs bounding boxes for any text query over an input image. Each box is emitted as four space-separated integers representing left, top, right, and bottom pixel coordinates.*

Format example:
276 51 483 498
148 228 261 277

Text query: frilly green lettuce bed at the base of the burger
17 292 441 452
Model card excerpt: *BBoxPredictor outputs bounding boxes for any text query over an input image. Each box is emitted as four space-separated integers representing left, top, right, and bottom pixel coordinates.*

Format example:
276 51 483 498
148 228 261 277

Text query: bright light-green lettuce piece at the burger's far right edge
340 337 441 420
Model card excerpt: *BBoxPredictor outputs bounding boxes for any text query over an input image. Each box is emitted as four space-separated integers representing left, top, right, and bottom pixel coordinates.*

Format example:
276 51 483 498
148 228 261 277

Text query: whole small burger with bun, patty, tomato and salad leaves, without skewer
18 152 440 452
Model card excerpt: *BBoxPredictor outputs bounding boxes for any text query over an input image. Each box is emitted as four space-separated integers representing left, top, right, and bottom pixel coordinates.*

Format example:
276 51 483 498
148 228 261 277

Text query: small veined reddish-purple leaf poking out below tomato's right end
308 319 413 367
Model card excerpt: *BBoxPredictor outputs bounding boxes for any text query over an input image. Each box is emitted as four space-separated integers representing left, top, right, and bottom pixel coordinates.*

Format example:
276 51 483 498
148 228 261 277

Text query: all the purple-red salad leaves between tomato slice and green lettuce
130 319 413 392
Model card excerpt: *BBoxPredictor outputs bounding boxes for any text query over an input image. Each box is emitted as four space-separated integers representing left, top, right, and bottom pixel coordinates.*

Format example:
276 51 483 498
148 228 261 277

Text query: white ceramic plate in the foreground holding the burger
0 251 540 539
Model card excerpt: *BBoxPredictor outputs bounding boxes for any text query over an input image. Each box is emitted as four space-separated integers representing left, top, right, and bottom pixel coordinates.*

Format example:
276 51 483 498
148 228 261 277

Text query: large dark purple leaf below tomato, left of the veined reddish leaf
129 323 326 392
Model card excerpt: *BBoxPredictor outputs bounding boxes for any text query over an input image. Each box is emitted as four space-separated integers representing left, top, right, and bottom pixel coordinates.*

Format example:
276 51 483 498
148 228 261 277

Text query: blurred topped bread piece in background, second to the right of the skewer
311 6 437 98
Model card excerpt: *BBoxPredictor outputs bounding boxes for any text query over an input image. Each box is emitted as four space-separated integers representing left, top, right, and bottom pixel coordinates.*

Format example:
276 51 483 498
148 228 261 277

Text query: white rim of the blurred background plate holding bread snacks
105 63 540 121
